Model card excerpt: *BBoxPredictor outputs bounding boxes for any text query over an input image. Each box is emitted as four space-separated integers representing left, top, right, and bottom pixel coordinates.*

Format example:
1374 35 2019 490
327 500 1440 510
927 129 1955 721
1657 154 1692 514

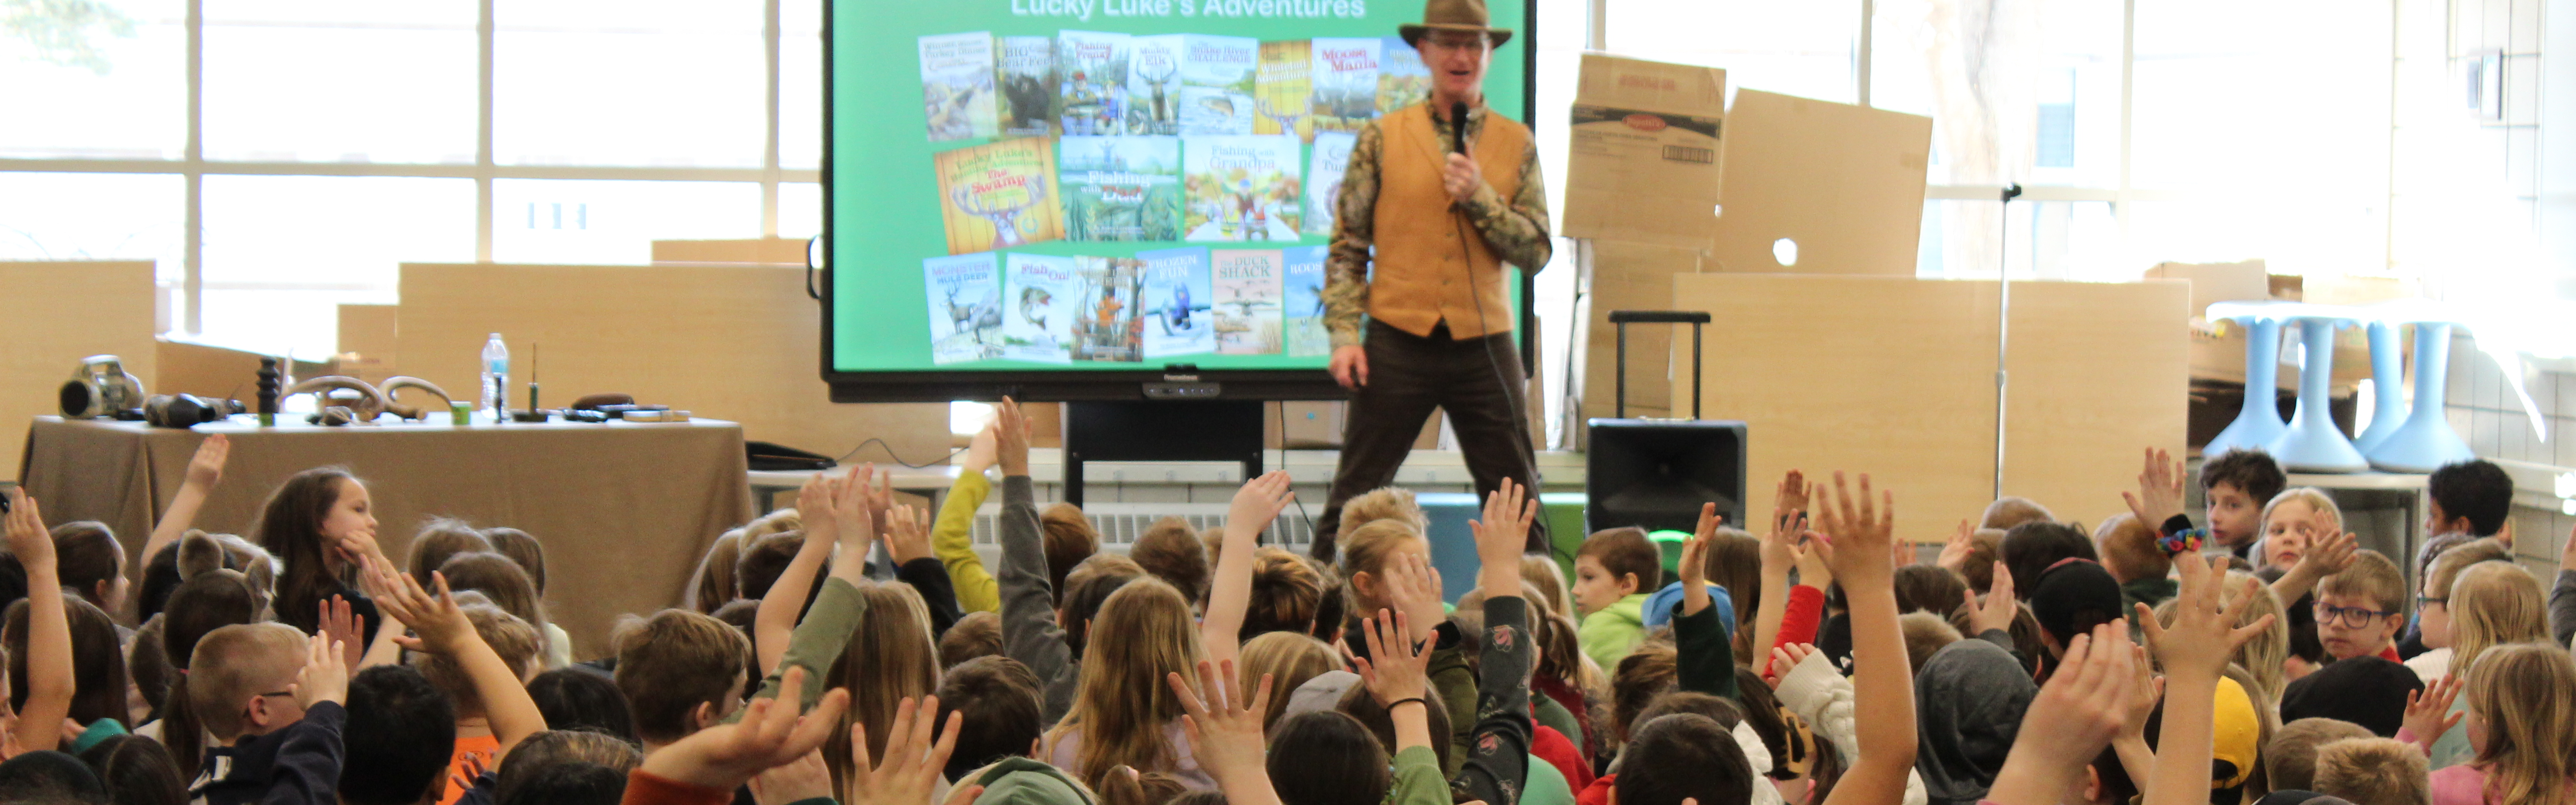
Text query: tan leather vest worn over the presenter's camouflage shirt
1368 103 1530 338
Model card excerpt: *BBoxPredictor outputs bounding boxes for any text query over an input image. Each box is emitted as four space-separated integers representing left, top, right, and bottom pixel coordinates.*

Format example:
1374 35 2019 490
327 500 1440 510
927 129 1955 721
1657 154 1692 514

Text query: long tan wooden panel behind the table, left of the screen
397 263 948 462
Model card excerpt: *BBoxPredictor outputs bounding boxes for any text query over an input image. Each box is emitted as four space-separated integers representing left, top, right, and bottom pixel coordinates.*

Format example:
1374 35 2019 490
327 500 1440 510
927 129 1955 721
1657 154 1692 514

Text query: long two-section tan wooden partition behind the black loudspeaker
1675 273 2187 542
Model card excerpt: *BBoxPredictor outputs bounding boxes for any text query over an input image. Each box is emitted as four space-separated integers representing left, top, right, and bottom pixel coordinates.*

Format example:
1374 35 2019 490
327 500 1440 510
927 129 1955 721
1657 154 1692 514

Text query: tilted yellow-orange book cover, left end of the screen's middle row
933 137 1064 255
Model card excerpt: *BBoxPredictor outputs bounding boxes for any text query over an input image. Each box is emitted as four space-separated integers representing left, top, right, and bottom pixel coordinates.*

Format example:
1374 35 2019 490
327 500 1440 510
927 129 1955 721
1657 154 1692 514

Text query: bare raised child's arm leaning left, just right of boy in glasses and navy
366 552 546 764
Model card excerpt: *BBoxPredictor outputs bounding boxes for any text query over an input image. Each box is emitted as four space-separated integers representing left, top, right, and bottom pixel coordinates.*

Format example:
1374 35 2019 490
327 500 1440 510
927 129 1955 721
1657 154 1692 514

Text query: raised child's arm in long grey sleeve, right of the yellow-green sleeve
994 398 1082 725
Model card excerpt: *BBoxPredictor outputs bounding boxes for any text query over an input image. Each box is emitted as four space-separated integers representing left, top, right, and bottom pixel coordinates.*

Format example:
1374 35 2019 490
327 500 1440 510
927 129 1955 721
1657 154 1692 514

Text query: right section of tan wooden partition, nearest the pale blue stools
1986 281 2192 526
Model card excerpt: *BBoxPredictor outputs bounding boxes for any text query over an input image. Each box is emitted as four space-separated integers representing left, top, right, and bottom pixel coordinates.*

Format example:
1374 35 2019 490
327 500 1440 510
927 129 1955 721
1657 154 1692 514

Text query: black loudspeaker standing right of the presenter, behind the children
1584 418 1744 532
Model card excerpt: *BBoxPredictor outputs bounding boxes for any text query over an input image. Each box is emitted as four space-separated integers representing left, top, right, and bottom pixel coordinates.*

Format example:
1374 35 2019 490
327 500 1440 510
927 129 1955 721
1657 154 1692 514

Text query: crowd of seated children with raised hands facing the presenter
0 400 2576 805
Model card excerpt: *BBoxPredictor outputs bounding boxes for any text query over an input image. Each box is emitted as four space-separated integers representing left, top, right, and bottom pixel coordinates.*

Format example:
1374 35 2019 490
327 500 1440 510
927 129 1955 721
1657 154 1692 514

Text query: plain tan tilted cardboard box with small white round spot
1705 90 1932 276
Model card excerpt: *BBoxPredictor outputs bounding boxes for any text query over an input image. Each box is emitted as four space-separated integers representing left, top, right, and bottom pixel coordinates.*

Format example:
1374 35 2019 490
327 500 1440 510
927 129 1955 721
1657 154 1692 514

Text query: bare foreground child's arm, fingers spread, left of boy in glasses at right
2138 552 2272 805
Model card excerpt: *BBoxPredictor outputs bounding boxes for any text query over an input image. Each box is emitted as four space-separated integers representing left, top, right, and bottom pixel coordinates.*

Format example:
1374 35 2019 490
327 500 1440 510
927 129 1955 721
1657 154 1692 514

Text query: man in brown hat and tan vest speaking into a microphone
1314 0 1551 560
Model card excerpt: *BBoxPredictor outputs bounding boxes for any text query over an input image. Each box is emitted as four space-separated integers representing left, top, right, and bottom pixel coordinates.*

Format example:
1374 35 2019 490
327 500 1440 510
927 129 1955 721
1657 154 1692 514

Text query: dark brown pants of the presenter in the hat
1314 320 1548 560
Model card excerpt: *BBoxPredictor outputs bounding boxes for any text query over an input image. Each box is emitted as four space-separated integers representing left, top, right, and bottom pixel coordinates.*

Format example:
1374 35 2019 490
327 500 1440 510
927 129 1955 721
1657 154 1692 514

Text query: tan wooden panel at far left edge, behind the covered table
0 260 160 478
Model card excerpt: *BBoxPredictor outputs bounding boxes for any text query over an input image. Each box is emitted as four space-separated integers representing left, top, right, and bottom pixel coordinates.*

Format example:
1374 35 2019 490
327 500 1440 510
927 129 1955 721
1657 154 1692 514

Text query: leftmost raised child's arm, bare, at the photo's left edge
8 487 80 751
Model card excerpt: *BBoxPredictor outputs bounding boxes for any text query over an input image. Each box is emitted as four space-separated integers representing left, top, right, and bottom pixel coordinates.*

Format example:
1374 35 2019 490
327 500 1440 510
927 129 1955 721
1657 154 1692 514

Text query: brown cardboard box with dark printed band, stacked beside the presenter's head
1561 54 1726 247
